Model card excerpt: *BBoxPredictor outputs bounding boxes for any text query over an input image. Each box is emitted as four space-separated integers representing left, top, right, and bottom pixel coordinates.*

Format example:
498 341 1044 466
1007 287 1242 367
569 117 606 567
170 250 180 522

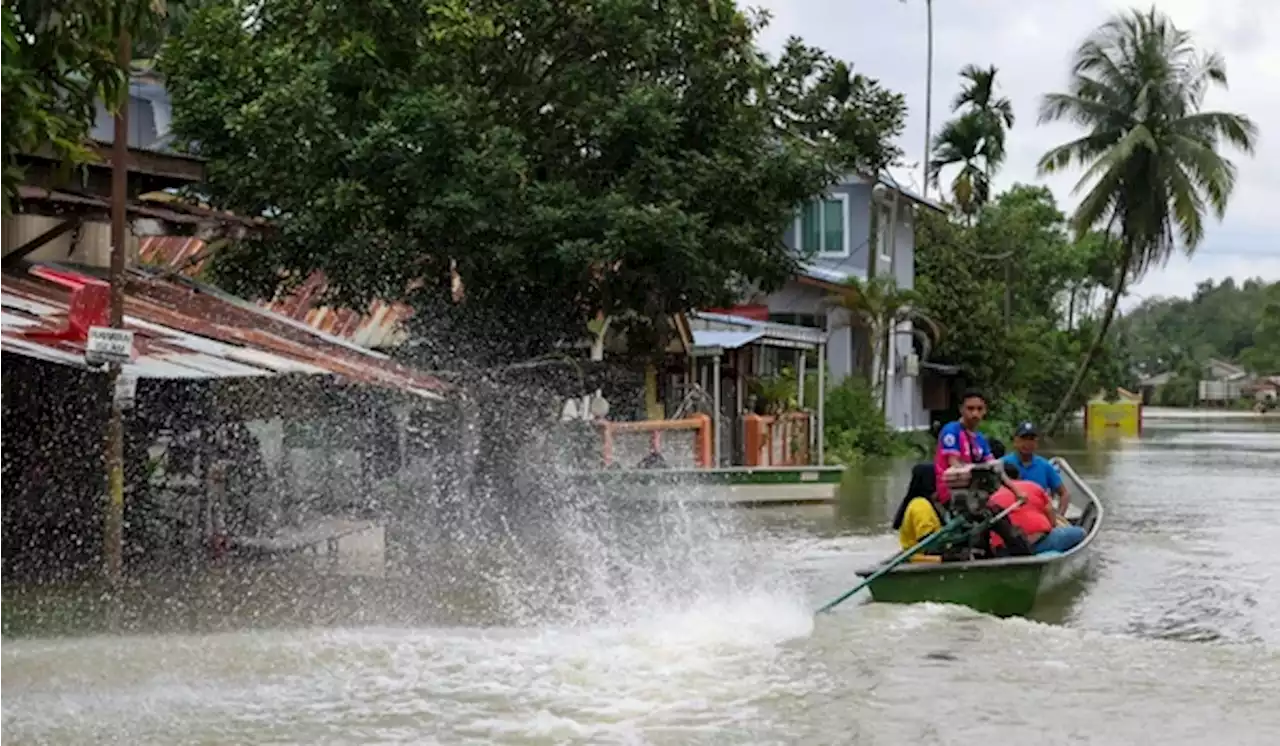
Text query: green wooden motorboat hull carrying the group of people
858 458 1103 617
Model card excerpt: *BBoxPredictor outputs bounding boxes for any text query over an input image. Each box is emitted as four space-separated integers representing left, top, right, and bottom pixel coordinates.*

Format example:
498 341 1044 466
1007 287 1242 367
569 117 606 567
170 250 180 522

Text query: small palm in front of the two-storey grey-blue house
823 275 942 413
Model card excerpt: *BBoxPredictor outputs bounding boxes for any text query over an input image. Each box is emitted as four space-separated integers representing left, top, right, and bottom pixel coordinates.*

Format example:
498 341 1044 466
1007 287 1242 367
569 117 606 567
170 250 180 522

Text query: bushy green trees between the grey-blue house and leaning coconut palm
916 186 1128 435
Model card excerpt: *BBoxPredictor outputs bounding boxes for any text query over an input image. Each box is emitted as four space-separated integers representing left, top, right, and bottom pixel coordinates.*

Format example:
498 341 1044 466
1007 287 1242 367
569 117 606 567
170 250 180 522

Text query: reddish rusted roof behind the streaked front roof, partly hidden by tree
138 235 413 349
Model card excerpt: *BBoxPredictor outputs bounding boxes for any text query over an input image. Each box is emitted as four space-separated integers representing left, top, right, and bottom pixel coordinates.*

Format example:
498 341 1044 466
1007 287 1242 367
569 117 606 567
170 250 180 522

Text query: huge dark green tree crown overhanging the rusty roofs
161 0 905 365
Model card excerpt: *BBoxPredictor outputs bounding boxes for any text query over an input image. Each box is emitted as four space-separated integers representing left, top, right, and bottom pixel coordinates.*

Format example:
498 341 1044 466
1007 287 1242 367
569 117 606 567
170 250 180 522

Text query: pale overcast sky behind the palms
744 0 1280 306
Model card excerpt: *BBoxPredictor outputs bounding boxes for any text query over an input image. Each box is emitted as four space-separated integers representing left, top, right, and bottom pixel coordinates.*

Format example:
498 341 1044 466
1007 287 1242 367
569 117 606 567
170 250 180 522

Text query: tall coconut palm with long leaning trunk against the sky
1039 8 1257 431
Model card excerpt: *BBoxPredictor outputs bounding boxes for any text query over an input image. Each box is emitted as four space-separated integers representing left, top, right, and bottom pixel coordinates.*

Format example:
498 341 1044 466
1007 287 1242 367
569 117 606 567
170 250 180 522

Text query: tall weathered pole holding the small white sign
102 27 131 586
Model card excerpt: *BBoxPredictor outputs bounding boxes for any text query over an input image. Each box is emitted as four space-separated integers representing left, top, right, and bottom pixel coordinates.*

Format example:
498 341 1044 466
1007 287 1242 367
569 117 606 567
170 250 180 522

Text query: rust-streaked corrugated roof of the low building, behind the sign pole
0 265 447 398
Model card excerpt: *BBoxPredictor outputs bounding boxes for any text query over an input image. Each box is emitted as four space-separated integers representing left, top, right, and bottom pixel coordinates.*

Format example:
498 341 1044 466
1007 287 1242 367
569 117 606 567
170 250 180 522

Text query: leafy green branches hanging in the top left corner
0 0 164 216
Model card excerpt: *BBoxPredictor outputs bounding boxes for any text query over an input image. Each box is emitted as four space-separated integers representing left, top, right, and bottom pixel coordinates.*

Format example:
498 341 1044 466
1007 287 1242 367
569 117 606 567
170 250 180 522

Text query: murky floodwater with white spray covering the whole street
0 417 1280 746
